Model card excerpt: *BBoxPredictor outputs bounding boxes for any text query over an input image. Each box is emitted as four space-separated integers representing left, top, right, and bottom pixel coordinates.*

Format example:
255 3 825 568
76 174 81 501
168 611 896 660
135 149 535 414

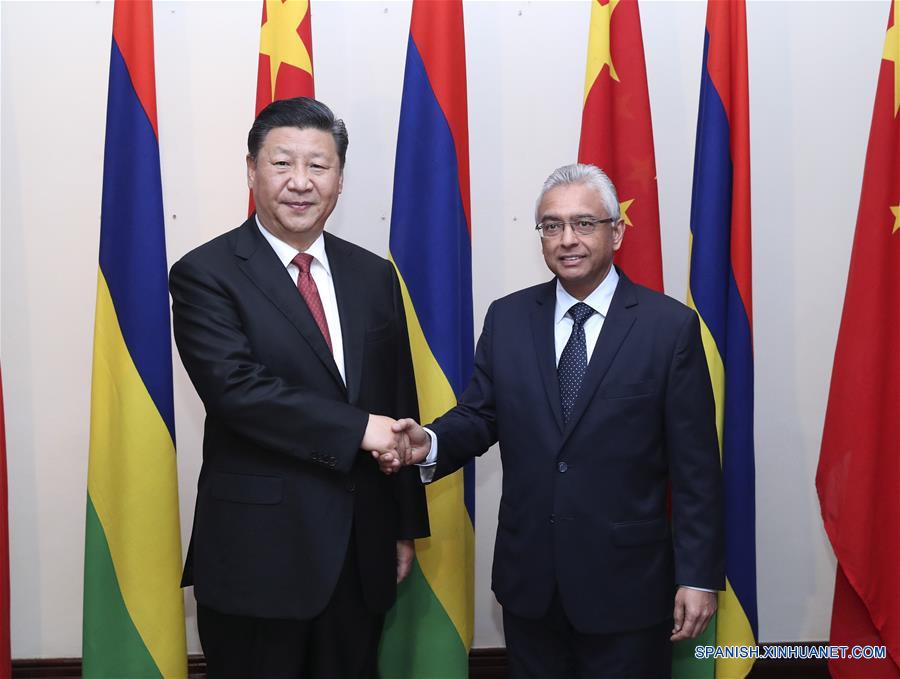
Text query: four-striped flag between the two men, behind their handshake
380 0 475 679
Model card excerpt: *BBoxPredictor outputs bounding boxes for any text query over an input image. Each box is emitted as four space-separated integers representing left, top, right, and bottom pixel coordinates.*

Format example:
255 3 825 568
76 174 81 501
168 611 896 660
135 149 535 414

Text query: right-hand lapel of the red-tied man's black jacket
325 233 366 403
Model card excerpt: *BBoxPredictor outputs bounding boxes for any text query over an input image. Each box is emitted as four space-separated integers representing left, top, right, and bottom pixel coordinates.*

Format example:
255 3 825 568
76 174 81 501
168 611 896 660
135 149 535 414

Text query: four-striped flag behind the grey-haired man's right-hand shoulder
673 0 758 679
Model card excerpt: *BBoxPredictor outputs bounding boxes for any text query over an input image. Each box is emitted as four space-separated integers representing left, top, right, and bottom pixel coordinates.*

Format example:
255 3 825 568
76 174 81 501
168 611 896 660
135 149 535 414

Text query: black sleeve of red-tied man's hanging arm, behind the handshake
390 265 430 539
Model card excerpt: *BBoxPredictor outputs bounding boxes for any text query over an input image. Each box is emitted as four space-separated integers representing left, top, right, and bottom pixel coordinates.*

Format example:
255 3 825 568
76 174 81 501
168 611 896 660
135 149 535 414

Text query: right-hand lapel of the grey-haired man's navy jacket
563 272 637 443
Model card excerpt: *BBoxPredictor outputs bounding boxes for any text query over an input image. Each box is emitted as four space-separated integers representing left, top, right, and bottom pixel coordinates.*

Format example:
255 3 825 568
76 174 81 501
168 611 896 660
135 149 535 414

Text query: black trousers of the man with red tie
197 537 384 679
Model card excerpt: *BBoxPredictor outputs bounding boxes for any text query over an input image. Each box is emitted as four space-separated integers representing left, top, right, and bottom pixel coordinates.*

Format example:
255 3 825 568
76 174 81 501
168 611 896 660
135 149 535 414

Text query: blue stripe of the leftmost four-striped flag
100 42 175 441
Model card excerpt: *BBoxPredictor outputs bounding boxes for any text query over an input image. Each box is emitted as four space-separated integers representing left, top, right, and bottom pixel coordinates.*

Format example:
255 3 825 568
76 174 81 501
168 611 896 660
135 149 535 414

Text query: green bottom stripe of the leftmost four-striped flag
82 495 162 679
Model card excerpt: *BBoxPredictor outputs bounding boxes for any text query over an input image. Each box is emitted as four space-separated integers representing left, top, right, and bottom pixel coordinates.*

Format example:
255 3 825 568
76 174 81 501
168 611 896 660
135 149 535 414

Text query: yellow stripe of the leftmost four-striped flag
88 271 187 677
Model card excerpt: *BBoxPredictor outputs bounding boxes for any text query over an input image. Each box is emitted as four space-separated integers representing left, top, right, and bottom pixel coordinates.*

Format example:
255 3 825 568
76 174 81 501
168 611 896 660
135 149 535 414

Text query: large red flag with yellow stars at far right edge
816 0 900 678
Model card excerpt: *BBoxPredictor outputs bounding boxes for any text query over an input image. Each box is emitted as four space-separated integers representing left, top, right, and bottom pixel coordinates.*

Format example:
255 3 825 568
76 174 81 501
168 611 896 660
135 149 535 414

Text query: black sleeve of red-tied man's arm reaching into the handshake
169 255 368 472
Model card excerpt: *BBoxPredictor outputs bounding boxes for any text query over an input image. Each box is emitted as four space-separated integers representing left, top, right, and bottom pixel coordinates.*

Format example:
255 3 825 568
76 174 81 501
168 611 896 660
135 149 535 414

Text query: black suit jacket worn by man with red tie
169 218 428 619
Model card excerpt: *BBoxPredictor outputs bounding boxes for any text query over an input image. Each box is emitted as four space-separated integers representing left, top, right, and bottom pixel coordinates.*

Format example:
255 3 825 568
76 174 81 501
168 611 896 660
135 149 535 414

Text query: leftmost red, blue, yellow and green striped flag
83 0 187 677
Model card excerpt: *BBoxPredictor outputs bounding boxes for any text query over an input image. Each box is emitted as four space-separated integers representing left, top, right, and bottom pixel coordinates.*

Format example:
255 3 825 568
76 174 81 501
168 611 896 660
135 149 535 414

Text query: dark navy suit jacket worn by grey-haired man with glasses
431 275 724 634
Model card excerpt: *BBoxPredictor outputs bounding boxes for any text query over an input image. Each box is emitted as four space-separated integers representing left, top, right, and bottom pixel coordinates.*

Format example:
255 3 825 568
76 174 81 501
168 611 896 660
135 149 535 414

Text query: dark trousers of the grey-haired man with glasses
503 594 672 679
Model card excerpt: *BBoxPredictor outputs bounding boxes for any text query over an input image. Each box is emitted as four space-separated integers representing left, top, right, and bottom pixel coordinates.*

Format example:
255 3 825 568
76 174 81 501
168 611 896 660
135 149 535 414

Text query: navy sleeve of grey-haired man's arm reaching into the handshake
428 304 497 480
